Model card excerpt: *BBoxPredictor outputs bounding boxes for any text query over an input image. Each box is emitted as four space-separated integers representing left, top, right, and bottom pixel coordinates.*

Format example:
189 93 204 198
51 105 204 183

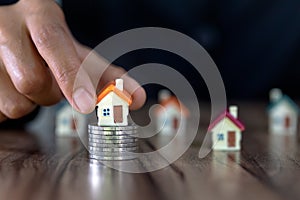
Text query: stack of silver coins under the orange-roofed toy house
88 124 138 160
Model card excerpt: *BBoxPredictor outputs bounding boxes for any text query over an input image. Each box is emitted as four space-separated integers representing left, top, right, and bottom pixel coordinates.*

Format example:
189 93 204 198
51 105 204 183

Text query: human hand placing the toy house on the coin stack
0 0 146 121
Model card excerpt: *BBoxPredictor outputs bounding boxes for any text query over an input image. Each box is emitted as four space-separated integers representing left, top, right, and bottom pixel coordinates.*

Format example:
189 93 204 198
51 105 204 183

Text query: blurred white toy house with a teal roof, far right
268 88 299 134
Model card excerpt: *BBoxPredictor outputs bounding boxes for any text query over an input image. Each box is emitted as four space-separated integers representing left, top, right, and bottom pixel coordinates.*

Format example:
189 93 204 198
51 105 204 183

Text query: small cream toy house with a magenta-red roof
208 106 245 151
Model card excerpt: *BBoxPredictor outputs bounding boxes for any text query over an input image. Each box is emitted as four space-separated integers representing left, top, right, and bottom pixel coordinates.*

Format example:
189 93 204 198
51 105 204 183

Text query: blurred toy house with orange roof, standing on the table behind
156 90 189 134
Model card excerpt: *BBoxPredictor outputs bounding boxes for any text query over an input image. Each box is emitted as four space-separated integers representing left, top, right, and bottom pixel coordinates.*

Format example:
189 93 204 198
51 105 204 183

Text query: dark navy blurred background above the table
63 0 300 100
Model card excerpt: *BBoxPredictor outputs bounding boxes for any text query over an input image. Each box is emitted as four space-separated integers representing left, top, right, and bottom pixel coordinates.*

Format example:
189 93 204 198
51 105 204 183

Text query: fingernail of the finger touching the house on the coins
73 87 95 113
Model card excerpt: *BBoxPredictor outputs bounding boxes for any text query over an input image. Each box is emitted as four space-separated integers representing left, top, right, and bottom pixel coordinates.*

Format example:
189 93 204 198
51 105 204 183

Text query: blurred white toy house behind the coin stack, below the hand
55 103 87 136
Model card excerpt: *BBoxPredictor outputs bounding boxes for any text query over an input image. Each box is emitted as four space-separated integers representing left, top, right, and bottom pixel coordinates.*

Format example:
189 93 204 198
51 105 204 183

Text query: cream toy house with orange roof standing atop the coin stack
96 79 132 126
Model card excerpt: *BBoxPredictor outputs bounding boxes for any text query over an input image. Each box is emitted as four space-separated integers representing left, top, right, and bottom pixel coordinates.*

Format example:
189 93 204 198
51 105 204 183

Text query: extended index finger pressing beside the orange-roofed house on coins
26 9 96 113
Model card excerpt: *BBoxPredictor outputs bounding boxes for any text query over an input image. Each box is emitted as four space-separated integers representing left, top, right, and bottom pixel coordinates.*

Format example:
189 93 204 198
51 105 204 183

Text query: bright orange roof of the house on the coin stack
97 81 132 105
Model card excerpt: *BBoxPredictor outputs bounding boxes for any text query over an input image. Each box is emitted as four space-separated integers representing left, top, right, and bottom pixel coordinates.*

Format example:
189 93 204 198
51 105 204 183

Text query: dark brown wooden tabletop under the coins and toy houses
0 102 300 200
